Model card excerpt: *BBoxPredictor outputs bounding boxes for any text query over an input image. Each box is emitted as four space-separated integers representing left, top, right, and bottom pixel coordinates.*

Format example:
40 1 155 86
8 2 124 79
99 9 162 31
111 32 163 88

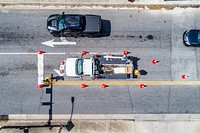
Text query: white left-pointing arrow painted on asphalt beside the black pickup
42 37 76 47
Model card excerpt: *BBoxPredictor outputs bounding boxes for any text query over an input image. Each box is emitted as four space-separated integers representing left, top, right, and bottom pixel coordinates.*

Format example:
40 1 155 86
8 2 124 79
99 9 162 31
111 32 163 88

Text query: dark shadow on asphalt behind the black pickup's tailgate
100 19 111 37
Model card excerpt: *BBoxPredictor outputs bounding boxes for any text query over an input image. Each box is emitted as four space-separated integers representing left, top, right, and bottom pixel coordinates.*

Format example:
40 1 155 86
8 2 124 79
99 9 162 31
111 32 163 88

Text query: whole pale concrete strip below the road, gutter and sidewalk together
0 114 200 133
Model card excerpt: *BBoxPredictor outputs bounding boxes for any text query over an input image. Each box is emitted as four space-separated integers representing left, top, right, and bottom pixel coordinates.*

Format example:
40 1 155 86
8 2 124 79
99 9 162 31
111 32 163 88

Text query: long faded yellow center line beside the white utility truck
47 80 200 85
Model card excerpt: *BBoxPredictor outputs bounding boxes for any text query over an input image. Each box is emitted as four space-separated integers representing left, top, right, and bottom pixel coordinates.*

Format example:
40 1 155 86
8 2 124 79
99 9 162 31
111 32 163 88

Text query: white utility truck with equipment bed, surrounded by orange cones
54 54 134 79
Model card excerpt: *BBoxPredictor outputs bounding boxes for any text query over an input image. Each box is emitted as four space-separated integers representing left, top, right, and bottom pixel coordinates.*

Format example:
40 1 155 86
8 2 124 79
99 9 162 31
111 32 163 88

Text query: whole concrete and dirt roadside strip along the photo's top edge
0 0 200 10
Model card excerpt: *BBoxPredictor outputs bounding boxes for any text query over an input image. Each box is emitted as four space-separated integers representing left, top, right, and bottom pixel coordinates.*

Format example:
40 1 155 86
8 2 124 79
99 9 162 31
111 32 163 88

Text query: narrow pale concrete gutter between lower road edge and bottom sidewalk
0 114 200 122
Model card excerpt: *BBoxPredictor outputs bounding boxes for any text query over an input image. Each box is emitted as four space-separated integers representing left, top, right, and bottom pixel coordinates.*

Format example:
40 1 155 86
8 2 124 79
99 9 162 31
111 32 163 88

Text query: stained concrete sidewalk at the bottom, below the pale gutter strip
0 120 200 133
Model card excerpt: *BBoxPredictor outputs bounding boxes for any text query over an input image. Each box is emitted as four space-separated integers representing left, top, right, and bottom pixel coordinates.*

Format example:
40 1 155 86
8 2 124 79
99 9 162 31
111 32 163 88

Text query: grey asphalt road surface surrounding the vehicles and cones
0 9 200 114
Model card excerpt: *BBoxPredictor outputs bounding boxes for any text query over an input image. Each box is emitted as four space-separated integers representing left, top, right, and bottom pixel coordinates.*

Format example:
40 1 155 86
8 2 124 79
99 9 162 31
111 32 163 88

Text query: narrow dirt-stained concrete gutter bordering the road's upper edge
0 2 200 10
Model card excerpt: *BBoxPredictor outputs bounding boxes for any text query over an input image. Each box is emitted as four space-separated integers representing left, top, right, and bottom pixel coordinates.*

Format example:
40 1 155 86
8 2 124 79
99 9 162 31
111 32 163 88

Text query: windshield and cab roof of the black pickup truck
58 15 84 30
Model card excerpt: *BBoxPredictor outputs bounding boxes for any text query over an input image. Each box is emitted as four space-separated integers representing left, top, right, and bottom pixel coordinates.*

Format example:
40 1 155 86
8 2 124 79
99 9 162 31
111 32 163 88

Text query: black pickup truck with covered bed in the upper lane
47 12 102 37
